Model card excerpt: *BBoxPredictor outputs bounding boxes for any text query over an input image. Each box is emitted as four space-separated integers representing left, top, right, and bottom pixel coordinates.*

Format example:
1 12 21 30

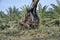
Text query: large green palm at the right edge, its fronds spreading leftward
47 0 60 26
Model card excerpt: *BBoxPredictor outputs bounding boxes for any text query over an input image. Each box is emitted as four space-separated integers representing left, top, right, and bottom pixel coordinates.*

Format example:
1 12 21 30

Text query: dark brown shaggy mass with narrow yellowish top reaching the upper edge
19 0 39 29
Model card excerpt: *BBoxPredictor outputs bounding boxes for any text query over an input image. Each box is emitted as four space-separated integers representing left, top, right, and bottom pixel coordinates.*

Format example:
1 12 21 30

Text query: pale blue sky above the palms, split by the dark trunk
0 0 57 12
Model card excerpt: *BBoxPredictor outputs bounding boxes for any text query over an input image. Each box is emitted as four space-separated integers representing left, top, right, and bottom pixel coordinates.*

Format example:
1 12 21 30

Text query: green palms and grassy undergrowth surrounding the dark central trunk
0 0 60 40
